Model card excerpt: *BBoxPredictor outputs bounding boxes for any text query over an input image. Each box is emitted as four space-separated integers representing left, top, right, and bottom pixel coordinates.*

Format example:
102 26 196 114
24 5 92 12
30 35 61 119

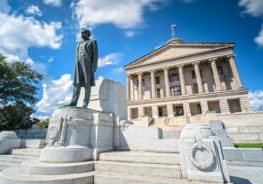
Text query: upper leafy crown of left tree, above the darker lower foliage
0 55 42 105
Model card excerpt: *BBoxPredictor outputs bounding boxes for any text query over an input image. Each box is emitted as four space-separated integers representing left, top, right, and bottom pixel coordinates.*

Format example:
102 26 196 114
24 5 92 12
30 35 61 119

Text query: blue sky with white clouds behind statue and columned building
0 0 263 116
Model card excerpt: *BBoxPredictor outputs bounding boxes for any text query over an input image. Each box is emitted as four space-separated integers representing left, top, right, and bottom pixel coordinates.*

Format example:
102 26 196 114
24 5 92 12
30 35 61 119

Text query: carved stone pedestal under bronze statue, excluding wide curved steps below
44 107 114 162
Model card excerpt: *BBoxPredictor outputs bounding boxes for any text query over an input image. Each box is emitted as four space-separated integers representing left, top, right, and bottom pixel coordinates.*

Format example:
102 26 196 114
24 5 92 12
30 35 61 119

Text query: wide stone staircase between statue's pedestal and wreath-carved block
94 151 219 184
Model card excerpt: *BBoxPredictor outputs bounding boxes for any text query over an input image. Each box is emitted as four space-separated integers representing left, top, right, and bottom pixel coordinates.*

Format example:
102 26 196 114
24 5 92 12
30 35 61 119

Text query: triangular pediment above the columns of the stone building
125 40 233 68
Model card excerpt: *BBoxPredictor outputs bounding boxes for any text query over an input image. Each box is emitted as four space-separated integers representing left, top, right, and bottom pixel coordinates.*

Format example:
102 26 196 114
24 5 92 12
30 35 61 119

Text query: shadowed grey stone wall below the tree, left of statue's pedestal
15 128 47 139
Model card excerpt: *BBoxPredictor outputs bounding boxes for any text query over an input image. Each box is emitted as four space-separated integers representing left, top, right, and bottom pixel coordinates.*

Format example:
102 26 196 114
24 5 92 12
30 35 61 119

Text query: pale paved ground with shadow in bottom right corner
227 165 263 184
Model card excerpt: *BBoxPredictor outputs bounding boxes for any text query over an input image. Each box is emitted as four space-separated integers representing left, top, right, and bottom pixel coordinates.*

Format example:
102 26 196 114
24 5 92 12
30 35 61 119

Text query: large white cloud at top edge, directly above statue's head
73 0 165 29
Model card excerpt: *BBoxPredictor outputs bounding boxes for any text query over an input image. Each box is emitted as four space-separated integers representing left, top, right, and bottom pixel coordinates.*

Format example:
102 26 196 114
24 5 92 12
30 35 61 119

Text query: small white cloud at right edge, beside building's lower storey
248 90 263 110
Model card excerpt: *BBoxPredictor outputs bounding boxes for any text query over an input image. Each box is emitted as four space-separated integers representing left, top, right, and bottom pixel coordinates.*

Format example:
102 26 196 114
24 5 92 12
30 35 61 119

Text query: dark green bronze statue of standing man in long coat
69 29 98 107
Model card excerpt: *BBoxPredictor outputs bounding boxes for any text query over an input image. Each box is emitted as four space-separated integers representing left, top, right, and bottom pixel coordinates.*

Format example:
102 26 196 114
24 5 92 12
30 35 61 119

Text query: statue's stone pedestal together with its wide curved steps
0 107 114 184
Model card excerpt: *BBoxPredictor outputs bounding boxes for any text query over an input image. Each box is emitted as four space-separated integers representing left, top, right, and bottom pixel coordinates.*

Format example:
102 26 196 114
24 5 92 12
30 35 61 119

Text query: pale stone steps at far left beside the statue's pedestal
0 140 43 172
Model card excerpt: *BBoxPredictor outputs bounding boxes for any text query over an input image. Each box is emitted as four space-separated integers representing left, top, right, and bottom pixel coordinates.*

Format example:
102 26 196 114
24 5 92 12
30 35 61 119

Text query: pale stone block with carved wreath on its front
180 124 230 183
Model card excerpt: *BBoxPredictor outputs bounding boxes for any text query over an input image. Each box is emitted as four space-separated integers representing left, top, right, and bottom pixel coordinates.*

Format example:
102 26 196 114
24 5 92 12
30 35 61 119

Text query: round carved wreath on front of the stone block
189 143 216 170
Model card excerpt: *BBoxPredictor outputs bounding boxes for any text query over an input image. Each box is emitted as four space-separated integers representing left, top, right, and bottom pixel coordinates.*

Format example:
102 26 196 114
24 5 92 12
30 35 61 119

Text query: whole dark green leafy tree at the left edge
0 55 43 131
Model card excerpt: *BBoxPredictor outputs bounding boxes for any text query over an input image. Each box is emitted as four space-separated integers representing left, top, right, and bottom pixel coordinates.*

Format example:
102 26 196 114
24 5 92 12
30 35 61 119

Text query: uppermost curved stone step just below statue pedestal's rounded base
20 160 94 175
